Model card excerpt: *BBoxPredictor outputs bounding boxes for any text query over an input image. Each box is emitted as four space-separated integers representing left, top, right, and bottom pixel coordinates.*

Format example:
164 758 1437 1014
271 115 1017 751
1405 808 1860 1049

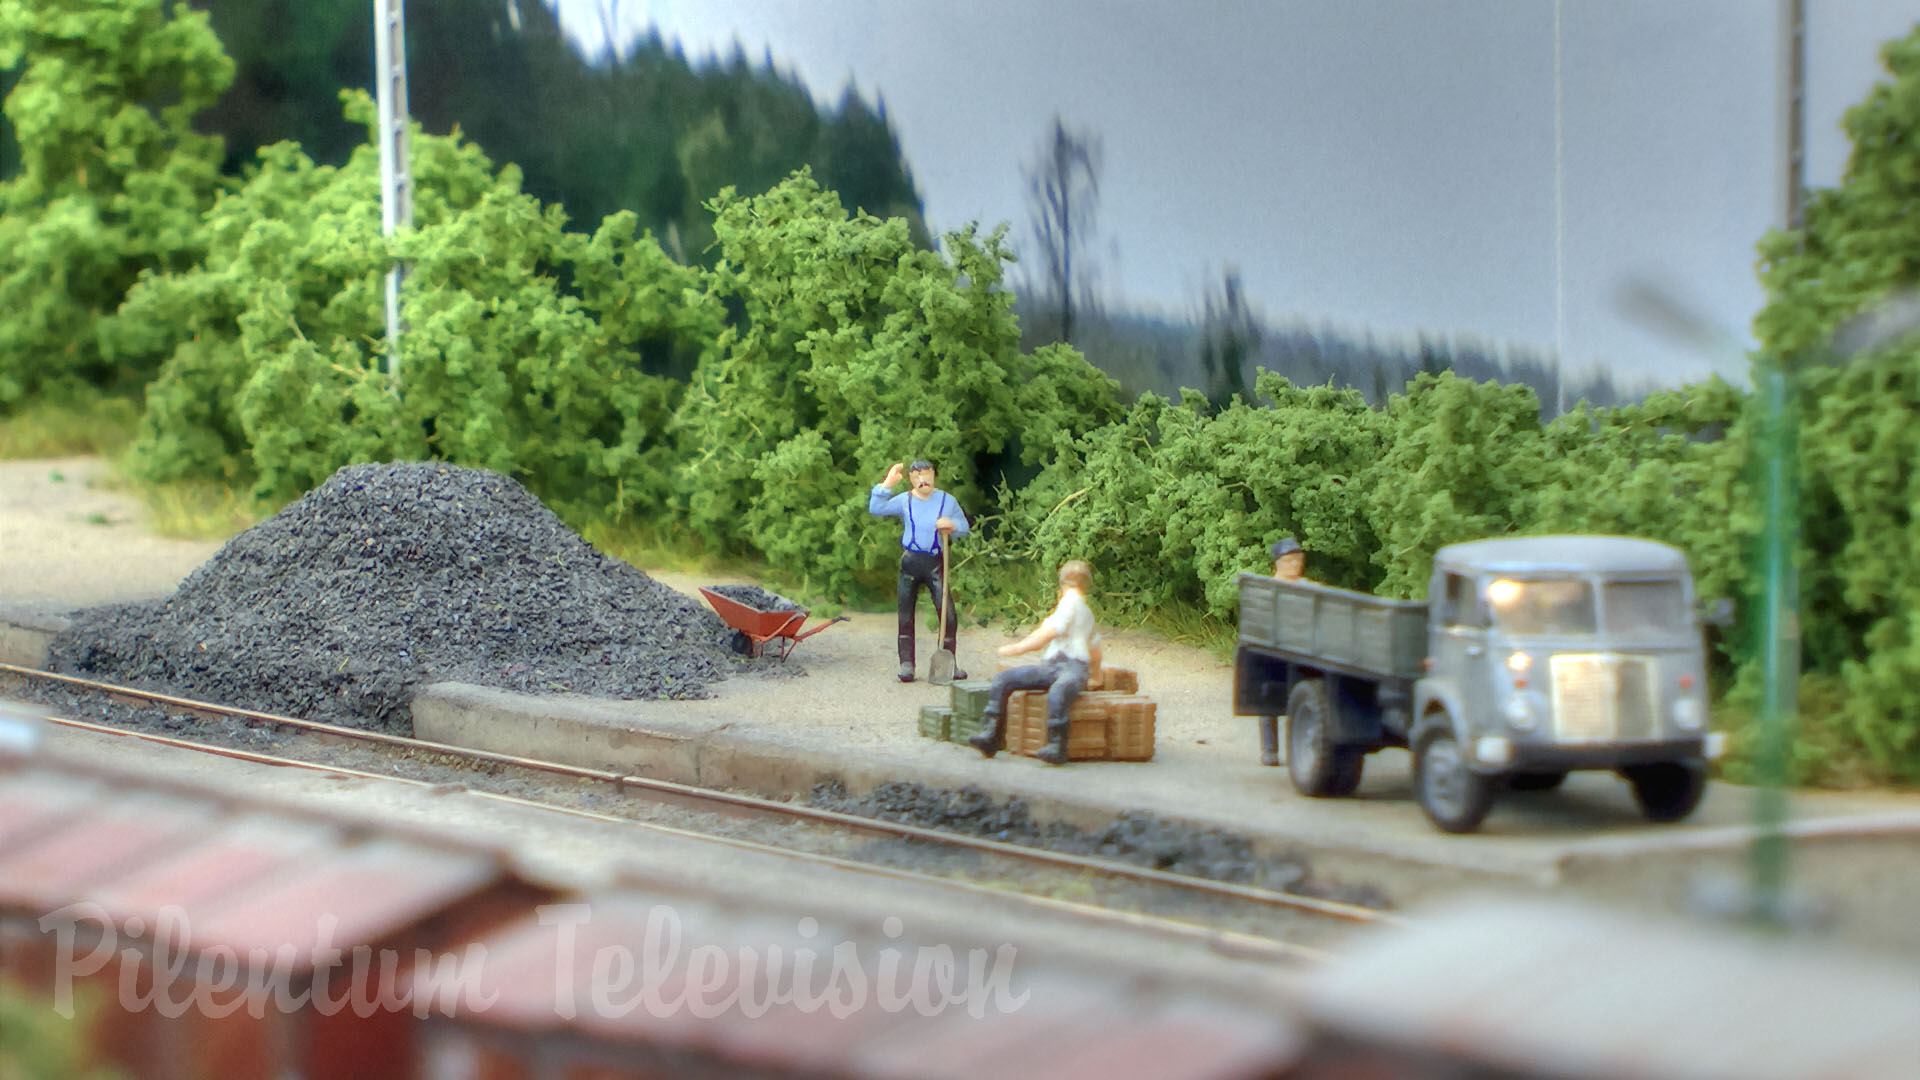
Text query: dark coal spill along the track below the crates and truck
808 780 1390 909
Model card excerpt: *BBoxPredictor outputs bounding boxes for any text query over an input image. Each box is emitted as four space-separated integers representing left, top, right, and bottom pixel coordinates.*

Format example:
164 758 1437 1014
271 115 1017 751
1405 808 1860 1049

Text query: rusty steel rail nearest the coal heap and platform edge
0 663 1409 926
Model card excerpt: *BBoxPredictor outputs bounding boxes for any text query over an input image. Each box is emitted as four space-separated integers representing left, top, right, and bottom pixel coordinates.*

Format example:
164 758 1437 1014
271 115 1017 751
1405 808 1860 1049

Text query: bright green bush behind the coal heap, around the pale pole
104 94 706 517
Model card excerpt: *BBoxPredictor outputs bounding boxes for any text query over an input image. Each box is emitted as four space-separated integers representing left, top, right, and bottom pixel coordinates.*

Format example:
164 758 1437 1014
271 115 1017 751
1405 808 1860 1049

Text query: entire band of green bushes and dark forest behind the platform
0 0 1920 782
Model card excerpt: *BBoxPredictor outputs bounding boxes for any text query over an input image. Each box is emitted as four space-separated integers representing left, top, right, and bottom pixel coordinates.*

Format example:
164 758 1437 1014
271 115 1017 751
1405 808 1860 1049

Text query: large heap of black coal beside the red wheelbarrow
50 463 764 732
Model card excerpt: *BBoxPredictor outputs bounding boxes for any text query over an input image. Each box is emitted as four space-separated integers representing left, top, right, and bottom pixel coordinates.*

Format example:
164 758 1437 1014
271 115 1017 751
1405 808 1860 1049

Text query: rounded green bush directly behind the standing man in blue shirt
674 169 1117 601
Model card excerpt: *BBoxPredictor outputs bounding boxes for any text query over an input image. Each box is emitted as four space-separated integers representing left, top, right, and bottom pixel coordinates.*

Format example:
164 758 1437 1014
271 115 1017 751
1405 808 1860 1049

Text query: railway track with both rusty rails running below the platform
0 665 1405 965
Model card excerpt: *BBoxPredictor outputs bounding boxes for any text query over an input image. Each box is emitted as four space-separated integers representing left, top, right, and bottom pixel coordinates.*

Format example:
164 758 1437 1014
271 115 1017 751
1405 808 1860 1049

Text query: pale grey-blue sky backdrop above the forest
557 0 1920 382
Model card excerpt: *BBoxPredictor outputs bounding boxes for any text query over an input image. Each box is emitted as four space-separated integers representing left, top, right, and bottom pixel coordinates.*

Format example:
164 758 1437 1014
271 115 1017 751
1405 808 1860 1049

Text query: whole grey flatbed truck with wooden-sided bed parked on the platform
1235 536 1722 832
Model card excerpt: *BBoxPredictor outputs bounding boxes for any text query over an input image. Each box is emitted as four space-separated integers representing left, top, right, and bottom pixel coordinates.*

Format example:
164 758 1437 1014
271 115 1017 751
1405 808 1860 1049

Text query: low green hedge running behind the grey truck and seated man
1006 371 1745 619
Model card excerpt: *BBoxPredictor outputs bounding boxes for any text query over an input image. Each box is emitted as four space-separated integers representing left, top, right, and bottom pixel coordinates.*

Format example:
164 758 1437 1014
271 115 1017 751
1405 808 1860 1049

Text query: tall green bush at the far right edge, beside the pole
1755 29 1920 782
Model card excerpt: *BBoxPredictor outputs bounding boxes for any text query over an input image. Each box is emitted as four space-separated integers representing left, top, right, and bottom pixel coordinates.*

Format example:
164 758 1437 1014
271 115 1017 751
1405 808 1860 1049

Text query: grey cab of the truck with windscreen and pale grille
1409 536 1720 828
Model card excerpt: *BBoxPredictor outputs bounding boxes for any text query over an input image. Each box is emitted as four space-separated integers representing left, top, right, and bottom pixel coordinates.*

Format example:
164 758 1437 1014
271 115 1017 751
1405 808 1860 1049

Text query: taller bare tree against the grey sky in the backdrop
1021 115 1100 344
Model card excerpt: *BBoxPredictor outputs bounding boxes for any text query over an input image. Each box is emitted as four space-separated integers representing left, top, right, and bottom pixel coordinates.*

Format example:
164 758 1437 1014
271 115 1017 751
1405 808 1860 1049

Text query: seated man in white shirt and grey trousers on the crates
968 559 1100 765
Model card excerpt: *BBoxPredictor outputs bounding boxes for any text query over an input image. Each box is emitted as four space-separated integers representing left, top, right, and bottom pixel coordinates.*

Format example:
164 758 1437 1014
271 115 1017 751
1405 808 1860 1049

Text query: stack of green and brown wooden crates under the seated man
920 667 1156 761
